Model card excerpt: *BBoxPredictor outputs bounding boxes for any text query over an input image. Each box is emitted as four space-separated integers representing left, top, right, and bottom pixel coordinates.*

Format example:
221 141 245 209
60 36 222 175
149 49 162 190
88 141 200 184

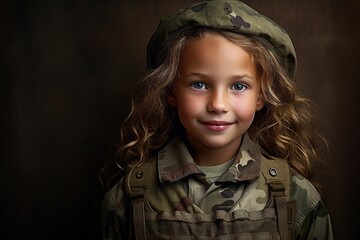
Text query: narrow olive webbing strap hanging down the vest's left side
132 197 146 240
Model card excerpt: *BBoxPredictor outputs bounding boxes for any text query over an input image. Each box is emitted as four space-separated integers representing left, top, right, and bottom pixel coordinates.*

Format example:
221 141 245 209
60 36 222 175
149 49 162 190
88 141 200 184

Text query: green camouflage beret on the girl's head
147 0 296 76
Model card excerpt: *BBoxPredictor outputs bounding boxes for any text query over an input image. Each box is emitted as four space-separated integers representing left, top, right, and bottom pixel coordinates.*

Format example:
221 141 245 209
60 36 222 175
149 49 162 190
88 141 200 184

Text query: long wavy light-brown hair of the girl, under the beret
100 28 326 188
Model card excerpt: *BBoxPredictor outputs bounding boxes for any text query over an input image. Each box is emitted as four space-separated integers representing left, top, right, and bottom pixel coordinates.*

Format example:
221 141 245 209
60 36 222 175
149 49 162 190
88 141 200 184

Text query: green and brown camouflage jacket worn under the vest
103 135 333 240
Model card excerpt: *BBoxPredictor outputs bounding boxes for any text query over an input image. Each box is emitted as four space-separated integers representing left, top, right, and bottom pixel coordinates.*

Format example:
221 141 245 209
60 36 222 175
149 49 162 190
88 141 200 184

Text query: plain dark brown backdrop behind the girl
0 0 360 239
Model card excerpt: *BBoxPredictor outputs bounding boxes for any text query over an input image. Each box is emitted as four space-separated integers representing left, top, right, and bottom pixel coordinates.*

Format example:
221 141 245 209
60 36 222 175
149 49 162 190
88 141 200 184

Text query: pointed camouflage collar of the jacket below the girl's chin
158 133 261 182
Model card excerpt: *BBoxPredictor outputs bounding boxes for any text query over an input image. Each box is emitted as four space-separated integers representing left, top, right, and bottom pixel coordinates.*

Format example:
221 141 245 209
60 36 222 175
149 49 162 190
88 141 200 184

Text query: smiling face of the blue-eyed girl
168 35 264 159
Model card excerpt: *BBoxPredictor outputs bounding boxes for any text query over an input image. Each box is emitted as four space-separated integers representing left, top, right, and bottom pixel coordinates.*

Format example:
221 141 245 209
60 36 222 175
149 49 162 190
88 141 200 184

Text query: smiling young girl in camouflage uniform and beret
103 0 332 239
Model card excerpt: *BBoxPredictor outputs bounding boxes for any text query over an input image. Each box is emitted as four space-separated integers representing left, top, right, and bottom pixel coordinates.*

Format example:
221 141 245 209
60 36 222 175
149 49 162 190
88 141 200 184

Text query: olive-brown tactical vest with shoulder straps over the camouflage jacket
126 157 296 240
